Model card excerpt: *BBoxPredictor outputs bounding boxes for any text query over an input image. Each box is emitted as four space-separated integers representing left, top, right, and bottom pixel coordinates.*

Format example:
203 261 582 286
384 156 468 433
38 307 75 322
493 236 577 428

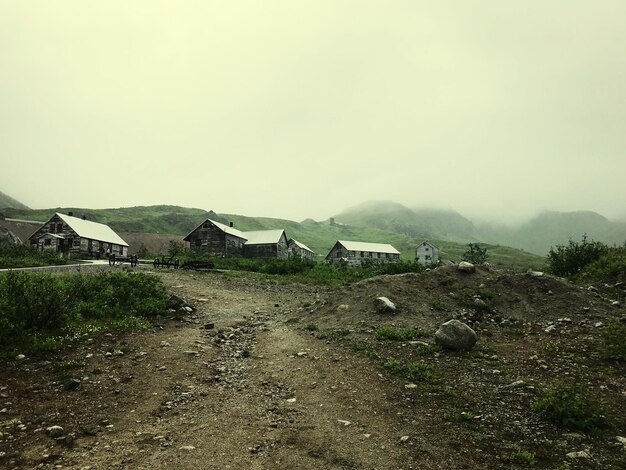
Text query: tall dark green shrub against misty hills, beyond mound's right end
548 235 609 277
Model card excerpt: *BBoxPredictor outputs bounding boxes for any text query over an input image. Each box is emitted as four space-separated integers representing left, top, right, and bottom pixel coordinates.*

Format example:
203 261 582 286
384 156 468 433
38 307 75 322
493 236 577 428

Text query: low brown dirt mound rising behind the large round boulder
309 266 614 330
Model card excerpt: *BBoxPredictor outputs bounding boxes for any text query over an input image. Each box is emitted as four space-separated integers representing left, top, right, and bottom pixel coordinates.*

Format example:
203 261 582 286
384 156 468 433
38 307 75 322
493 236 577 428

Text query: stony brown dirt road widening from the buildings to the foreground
0 273 420 469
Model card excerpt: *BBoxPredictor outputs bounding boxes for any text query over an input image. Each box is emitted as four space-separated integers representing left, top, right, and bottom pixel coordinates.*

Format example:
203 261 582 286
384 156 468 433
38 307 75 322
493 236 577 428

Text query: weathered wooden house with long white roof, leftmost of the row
29 212 128 256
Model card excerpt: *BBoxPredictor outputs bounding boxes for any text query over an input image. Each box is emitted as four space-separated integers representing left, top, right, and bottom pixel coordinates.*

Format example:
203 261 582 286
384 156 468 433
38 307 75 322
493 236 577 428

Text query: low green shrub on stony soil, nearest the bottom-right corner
531 381 607 431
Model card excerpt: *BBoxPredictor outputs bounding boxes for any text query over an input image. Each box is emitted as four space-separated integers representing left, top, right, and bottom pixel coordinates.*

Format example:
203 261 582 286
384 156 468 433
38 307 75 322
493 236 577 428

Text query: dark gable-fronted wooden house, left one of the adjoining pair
183 219 247 256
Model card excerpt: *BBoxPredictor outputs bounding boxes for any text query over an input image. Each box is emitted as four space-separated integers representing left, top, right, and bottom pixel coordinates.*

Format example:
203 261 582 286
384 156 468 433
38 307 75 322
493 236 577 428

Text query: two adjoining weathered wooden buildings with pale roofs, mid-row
183 219 289 258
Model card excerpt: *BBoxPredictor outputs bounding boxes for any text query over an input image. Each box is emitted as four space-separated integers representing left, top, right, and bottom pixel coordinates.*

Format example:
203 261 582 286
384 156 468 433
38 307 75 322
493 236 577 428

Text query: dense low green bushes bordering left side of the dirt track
0 271 167 351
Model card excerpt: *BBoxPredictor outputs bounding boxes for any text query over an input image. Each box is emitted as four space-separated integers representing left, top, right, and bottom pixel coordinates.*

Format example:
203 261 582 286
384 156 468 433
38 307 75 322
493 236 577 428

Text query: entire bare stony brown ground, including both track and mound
0 267 626 469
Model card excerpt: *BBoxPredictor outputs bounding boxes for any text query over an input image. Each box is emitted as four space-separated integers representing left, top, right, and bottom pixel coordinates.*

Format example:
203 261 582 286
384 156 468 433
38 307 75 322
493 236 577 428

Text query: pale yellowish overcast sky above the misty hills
0 0 626 221
